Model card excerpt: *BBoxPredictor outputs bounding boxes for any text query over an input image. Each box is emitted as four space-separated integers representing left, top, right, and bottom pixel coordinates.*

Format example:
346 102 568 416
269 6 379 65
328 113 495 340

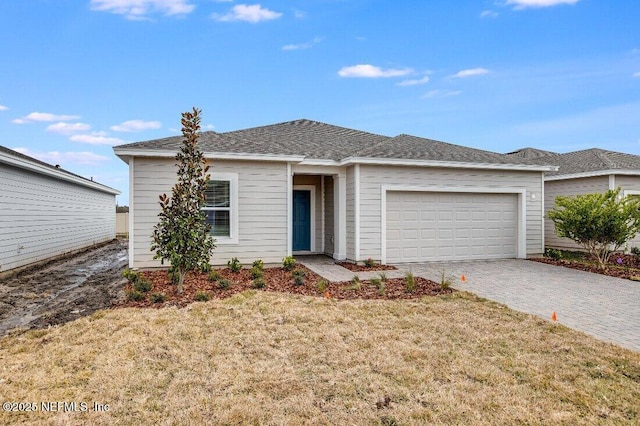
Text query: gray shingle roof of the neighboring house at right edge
506 148 640 180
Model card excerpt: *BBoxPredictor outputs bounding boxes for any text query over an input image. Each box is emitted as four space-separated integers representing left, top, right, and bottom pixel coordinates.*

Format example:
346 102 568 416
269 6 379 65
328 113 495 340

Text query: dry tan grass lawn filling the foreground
0 291 640 425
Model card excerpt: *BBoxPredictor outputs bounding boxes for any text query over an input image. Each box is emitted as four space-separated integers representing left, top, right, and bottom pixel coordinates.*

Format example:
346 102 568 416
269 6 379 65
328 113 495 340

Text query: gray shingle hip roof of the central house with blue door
114 119 553 170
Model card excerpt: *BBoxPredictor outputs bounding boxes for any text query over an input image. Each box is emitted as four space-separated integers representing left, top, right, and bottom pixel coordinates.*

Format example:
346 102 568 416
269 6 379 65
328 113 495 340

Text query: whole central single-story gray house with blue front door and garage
114 119 555 267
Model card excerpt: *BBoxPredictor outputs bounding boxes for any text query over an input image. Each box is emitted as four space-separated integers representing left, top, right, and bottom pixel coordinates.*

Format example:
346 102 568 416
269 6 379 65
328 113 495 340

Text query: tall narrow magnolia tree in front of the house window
151 108 215 293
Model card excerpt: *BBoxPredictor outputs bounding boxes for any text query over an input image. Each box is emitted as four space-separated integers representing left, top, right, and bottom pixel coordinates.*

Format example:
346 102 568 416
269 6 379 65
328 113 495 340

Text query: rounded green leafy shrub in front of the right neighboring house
547 188 640 269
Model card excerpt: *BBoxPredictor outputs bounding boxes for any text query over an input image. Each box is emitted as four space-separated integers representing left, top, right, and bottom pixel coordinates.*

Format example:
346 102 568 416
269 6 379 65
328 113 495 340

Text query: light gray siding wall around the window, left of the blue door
131 157 287 267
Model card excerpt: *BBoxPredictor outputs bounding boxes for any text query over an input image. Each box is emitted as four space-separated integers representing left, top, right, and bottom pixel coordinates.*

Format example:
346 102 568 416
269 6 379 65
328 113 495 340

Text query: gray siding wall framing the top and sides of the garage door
360 165 543 259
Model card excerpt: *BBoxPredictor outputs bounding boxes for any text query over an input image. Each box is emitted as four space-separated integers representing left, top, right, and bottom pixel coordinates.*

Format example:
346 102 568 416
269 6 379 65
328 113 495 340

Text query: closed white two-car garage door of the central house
386 191 518 263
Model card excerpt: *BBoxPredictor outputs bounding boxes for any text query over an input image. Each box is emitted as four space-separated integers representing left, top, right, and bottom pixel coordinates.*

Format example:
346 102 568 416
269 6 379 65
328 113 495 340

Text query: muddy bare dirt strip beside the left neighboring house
0 239 128 336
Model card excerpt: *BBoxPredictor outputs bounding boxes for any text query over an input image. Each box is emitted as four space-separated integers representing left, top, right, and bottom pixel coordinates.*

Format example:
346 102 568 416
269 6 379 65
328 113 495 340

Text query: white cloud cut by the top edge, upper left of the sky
91 0 195 20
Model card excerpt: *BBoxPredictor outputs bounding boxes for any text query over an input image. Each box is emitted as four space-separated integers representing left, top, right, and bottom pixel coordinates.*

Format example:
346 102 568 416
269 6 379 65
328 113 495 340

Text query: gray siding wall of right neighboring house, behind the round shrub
544 176 609 250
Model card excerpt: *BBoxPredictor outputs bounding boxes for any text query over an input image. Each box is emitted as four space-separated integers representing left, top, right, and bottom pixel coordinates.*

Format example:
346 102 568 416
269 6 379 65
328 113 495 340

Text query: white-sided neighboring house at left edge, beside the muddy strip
0 146 120 272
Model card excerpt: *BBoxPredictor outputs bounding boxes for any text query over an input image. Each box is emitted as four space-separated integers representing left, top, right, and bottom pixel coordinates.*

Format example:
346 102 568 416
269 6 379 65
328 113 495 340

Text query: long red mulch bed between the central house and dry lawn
118 265 453 308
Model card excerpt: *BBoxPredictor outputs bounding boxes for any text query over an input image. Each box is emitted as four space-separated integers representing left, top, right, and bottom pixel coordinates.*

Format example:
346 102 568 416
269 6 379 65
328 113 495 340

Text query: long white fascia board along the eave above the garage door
340 157 558 172
